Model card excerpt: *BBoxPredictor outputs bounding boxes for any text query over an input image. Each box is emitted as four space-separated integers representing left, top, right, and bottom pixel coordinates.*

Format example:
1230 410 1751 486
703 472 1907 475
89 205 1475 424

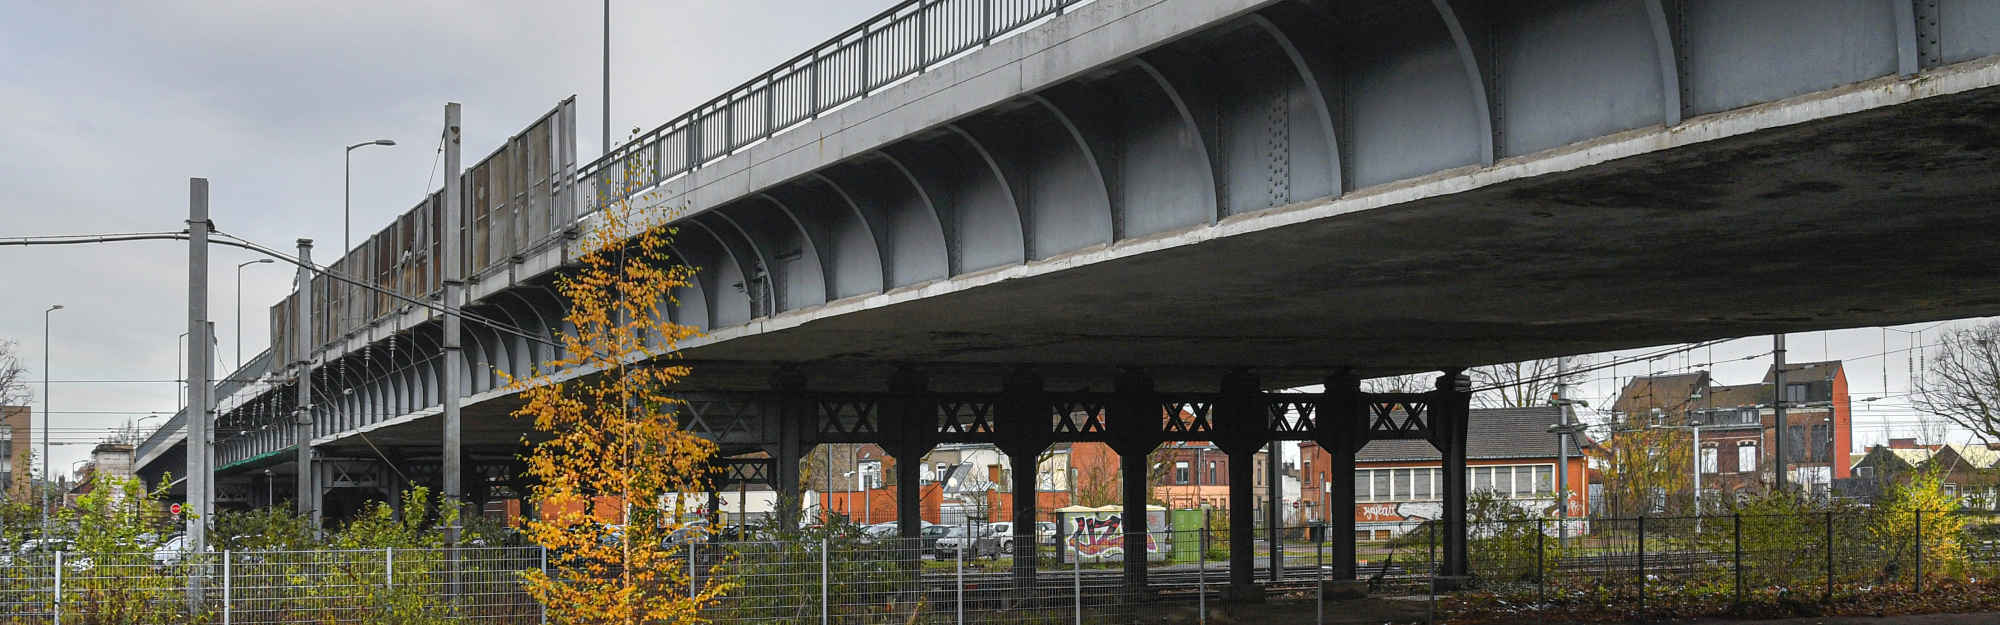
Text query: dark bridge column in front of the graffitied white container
1108 369 1164 595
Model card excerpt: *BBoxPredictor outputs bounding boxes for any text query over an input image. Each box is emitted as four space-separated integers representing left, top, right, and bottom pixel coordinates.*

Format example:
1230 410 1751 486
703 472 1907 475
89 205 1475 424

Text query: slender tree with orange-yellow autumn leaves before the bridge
510 191 728 625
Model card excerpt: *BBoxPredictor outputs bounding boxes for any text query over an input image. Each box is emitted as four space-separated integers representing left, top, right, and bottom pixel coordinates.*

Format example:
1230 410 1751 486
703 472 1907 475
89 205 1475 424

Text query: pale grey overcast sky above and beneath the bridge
0 0 2000 480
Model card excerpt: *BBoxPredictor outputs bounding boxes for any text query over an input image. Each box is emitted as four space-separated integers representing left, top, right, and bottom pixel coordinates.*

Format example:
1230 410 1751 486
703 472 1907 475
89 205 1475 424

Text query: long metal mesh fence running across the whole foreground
0 511 2000 625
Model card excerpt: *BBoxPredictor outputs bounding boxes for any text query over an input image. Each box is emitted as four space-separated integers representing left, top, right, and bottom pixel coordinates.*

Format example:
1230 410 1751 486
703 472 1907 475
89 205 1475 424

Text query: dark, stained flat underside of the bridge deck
652 81 2000 391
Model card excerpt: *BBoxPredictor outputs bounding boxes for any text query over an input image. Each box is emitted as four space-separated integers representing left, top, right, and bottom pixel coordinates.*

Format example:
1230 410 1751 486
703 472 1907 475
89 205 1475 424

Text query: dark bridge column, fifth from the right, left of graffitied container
994 367 1050 599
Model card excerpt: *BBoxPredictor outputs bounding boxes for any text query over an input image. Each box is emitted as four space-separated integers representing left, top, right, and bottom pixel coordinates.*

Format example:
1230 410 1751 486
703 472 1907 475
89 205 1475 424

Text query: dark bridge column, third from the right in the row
1214 371 1268 603
